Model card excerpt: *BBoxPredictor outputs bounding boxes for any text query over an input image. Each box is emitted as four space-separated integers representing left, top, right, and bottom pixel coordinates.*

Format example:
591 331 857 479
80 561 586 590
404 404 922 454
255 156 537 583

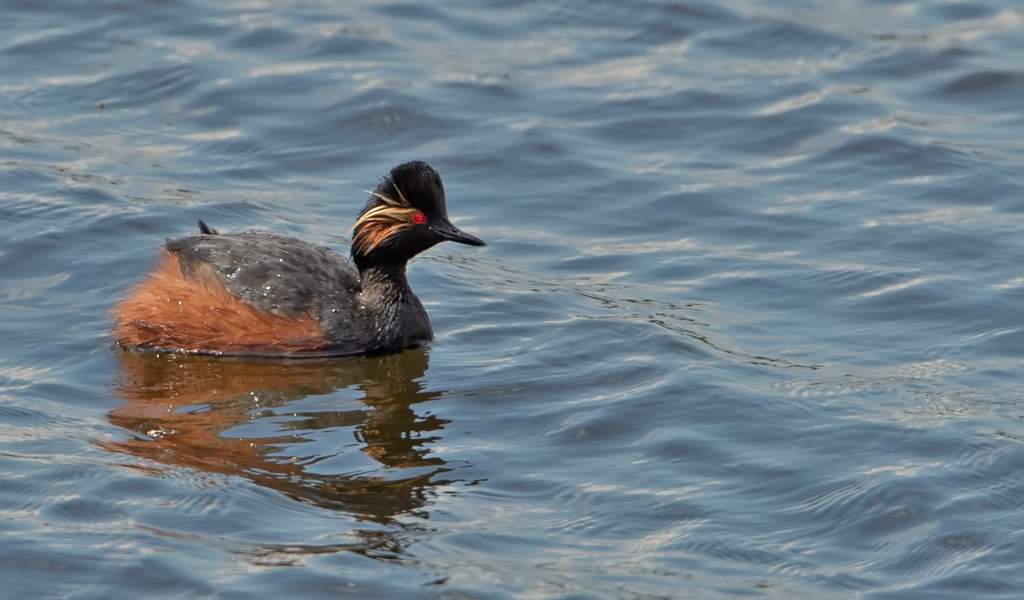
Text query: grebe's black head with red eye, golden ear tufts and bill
352 161 485 269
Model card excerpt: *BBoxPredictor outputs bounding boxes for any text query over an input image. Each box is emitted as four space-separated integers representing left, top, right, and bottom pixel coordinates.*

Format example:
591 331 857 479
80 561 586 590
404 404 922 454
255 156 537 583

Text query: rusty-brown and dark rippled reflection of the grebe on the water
101 349 450 552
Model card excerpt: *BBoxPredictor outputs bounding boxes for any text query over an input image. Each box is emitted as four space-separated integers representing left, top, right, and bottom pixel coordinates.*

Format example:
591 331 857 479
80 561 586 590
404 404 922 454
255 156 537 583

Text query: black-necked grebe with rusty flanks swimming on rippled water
114 161 484 355
